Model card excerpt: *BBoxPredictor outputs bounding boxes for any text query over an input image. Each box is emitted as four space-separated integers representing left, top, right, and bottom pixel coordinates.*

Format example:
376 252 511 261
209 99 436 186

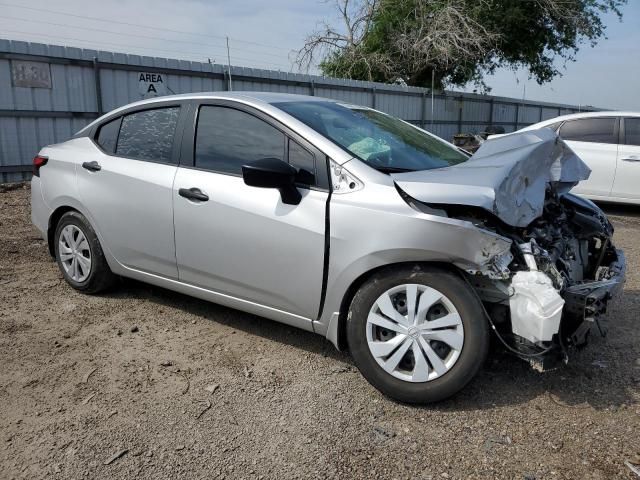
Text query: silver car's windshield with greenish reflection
274 101 469 173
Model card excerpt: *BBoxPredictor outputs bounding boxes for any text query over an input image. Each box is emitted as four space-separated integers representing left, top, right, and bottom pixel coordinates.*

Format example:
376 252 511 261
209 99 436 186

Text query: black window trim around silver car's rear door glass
86 100 190 167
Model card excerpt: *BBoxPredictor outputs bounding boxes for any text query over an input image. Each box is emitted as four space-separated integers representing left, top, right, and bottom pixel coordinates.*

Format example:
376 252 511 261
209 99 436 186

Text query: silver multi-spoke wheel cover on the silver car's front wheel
366 284 464 383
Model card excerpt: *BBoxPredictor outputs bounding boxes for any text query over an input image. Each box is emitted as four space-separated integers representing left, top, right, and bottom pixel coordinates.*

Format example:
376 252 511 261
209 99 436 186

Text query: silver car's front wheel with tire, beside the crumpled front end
347 265 489 403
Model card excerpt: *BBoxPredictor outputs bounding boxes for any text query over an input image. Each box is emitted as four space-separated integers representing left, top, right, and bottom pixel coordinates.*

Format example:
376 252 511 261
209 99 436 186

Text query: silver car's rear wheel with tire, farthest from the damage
54 211 116 293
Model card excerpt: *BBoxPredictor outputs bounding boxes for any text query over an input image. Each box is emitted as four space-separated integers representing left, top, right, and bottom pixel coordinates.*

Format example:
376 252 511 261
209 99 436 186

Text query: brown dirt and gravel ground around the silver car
0 186 640 480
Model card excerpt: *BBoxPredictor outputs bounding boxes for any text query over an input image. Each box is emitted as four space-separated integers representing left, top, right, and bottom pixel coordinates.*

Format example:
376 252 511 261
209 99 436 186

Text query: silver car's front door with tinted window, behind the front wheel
173 102 329 319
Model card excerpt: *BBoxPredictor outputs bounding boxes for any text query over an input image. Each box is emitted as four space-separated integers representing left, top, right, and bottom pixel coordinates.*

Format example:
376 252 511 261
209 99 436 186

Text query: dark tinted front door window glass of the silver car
195 105 285 175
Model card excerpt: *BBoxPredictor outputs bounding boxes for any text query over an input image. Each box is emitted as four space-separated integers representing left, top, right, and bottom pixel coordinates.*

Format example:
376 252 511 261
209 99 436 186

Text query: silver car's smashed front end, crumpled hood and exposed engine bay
395 127 625 369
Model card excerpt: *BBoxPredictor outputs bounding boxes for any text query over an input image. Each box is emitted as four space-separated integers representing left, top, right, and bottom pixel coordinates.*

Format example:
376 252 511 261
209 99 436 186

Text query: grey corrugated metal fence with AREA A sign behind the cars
0 39 596 183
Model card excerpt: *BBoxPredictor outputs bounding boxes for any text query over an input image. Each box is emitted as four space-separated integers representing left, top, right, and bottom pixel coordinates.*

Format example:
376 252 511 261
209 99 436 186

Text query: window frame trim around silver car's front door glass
179 99 330 192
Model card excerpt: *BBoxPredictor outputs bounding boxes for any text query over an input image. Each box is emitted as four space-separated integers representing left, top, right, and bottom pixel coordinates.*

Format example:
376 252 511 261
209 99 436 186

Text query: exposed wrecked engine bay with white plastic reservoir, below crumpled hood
444 189 625 368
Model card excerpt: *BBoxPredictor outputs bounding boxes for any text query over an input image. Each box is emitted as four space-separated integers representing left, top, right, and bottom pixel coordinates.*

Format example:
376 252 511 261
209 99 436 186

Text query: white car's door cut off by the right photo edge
611 117 640 201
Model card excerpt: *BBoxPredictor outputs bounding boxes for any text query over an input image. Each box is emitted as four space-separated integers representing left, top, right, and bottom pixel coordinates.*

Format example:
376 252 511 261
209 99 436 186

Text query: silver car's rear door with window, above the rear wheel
76 104 185 278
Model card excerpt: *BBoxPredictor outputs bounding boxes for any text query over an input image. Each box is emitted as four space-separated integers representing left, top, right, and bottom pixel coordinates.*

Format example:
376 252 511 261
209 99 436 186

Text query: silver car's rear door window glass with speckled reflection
115 107 180 162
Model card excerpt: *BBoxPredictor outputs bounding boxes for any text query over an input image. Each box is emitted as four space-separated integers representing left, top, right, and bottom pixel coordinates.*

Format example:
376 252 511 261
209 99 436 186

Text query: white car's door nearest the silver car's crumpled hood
558 117 619 197
